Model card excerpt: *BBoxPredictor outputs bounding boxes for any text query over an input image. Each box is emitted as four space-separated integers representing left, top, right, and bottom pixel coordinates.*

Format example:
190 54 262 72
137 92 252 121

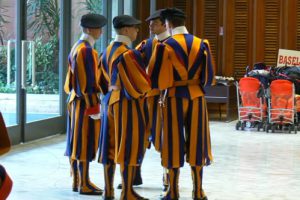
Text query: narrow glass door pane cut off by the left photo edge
0 0 17 126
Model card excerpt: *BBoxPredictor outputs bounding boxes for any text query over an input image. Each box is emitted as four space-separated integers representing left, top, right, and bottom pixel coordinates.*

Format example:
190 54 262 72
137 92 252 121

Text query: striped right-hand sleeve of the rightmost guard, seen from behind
200 39 215 86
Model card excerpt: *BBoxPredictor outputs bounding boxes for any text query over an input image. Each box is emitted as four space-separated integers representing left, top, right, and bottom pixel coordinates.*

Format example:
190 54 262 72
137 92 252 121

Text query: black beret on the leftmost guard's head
80 13 107 28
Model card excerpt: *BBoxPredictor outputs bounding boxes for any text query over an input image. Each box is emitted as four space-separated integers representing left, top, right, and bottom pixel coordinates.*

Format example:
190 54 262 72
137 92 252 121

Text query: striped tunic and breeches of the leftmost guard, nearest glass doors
64 40 100 161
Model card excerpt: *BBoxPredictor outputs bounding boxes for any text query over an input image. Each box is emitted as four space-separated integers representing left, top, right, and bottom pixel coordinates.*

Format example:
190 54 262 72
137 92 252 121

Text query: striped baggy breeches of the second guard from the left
99 98 146 166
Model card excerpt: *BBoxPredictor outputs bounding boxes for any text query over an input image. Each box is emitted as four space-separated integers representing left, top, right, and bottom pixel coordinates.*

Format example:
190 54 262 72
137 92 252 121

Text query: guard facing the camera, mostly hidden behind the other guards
134 9 170 191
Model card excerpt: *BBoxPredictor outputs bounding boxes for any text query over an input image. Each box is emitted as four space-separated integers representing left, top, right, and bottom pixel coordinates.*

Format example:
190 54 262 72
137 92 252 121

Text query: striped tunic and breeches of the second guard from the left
98 42 151 166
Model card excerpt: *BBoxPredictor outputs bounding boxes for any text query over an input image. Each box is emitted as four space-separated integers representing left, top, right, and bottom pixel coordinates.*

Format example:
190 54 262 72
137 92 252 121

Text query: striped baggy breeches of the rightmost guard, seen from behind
161 97 212 168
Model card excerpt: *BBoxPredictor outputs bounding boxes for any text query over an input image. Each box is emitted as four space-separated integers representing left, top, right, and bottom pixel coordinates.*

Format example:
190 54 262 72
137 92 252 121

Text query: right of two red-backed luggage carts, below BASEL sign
266 79 298 134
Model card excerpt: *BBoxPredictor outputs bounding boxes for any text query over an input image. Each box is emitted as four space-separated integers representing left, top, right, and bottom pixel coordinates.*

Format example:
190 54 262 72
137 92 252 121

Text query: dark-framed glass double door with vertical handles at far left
0 0 65 144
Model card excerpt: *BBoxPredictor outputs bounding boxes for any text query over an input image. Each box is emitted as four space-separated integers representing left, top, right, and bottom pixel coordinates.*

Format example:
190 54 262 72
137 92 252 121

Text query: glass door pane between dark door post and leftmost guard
22 0 60 122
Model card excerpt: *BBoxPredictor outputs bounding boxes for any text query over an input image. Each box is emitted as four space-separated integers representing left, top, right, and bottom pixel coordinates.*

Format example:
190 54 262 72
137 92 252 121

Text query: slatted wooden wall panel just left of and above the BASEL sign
264 0 280 65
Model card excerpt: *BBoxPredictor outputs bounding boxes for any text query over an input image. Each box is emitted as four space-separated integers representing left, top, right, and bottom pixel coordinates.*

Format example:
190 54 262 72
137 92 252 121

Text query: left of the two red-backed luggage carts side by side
236 77 267 131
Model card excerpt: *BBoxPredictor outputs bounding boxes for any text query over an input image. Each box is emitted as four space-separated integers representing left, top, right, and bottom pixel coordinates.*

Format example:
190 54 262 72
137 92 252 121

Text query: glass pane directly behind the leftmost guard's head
71 0 104 52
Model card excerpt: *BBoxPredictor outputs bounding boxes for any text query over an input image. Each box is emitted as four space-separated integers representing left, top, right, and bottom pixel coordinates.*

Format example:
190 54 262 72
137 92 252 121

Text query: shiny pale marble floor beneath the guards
0 121 300 200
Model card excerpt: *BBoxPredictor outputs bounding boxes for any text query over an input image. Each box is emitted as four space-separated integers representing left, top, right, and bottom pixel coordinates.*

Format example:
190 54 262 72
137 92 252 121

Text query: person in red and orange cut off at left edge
0 112 13 200
